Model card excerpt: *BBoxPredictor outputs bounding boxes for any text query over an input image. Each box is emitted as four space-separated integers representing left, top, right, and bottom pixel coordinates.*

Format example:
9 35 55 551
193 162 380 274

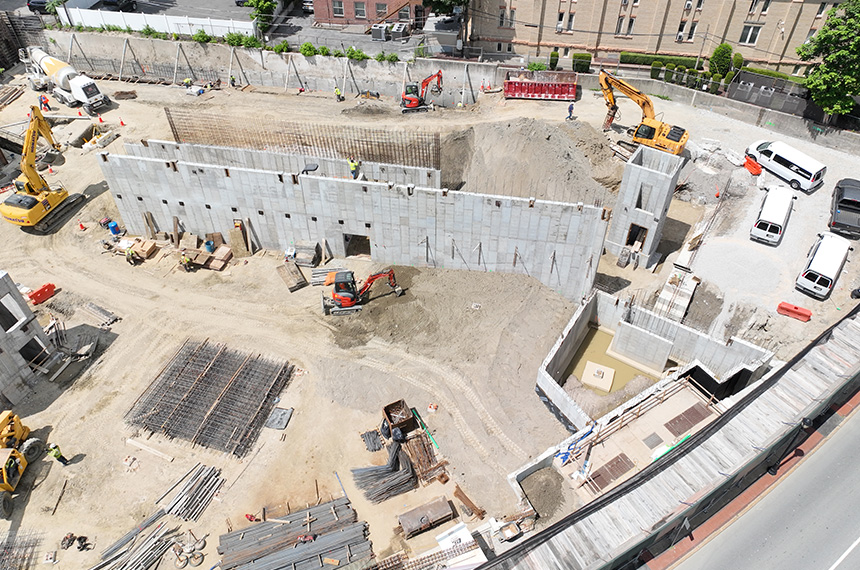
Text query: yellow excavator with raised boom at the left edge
0 105 84 233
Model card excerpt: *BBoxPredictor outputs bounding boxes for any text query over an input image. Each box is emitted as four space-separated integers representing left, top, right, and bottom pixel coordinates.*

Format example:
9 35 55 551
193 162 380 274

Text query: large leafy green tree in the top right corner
797 0 860 115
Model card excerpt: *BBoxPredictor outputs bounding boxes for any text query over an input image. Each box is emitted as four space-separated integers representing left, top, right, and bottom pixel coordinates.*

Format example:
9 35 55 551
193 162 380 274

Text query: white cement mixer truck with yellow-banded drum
18 47 110 115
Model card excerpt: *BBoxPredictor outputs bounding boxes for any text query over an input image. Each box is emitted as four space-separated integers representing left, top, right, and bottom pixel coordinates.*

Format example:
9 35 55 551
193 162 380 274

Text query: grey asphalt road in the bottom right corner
675 412 860 570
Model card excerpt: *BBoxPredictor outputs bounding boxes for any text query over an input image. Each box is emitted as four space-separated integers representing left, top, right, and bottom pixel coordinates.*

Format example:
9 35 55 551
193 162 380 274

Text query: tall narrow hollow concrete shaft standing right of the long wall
606 146 684 267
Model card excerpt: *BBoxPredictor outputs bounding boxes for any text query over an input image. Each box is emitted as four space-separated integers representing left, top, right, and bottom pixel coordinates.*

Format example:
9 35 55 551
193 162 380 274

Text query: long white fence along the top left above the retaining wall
57 7 256 37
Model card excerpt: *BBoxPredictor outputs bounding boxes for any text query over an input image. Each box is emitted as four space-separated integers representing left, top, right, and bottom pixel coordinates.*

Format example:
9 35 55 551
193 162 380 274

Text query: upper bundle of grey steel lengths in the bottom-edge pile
218 497 358 570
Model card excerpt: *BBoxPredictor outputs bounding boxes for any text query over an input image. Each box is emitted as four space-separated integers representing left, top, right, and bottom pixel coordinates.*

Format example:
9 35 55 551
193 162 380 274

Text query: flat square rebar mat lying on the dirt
125 340 292 457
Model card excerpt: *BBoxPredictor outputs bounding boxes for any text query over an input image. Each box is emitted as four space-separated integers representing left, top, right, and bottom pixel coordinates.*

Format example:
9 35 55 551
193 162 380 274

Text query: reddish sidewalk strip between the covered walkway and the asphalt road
641 386 860 570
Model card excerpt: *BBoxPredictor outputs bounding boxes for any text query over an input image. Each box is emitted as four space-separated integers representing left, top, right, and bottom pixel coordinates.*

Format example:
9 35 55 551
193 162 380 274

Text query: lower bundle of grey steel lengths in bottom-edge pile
221 521 373 570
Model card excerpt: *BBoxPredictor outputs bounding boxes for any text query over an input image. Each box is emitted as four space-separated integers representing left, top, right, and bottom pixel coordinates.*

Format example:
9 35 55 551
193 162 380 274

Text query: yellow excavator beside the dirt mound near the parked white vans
599 69 690 154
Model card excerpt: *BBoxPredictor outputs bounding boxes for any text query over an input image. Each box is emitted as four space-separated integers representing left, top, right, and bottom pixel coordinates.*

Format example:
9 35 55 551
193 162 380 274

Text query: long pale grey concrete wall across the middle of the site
100 144 606 300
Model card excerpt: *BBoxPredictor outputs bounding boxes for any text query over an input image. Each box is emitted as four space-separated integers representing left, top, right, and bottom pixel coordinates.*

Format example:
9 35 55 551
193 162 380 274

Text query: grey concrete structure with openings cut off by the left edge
0 271 53 404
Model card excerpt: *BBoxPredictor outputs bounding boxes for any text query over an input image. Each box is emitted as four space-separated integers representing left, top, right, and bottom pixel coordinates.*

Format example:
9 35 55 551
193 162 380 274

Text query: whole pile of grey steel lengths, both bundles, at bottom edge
218 497 372 570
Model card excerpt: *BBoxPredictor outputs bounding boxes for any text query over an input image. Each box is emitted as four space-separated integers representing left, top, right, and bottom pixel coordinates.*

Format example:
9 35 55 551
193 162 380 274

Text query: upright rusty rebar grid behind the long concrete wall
164 107 442 170
